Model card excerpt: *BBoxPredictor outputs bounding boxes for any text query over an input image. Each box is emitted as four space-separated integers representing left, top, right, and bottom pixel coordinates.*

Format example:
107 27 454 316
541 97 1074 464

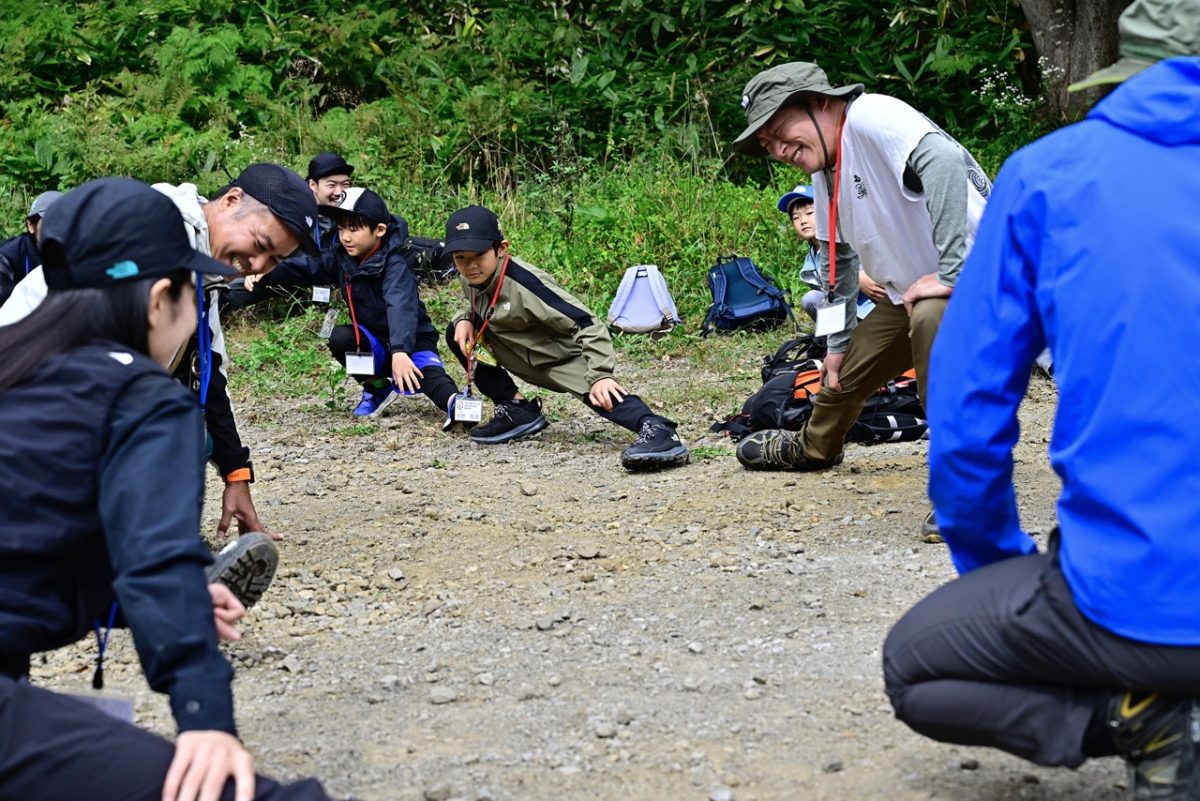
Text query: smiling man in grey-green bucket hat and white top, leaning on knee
733 61 990 537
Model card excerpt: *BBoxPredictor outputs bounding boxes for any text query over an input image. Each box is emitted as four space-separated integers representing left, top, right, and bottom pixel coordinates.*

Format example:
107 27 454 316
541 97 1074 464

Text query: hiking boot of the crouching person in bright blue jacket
1108 692 1200 801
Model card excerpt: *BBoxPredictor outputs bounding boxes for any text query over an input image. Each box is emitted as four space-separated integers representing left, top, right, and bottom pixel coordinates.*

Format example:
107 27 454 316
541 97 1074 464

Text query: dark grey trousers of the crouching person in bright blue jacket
883 546 1200 767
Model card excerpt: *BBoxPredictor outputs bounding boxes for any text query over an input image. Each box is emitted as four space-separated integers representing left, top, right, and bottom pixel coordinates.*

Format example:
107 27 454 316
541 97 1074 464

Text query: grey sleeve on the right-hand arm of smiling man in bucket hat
907 133 967 287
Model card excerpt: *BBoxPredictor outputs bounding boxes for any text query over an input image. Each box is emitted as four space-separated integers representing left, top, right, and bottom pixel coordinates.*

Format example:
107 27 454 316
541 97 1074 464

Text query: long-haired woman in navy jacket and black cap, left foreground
0 179 326 801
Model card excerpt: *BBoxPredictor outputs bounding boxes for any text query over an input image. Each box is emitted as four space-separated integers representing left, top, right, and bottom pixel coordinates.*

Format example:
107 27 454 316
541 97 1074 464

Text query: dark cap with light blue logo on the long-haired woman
41 177 238 290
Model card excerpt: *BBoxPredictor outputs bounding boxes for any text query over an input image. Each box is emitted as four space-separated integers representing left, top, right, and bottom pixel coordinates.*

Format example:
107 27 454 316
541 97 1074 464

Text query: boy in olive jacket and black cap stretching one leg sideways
445 206 690 470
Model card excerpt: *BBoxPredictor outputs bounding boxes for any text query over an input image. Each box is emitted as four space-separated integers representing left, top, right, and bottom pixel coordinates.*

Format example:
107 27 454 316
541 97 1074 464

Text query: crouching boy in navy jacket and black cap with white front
253 187 457 417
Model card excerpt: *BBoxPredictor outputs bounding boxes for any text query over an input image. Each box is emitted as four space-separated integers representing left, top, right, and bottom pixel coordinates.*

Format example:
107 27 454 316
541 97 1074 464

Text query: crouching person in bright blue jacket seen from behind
883 0 1200 800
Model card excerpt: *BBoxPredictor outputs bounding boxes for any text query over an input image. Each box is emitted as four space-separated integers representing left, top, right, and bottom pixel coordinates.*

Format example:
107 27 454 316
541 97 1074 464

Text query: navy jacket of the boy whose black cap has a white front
262 217 438 356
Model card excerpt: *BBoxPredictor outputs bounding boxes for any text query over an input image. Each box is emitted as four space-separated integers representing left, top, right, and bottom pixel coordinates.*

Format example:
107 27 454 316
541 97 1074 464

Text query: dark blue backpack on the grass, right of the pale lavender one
700 255 796 336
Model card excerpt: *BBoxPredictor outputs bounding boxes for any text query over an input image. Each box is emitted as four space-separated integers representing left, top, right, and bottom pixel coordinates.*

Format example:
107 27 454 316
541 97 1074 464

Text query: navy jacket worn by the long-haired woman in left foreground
0 343 235 734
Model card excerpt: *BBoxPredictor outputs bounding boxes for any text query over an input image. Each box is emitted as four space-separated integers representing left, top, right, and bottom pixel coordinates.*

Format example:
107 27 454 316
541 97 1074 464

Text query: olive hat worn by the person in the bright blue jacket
1067 0 1200 92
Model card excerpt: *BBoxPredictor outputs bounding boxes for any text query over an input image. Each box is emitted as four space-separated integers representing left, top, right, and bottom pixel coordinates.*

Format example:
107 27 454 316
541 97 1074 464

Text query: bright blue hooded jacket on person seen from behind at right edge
928 58 1200 645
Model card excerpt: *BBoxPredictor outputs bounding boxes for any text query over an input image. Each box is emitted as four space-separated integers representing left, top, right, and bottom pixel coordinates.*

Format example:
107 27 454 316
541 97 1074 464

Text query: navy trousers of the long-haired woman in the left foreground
0 674 329 801
